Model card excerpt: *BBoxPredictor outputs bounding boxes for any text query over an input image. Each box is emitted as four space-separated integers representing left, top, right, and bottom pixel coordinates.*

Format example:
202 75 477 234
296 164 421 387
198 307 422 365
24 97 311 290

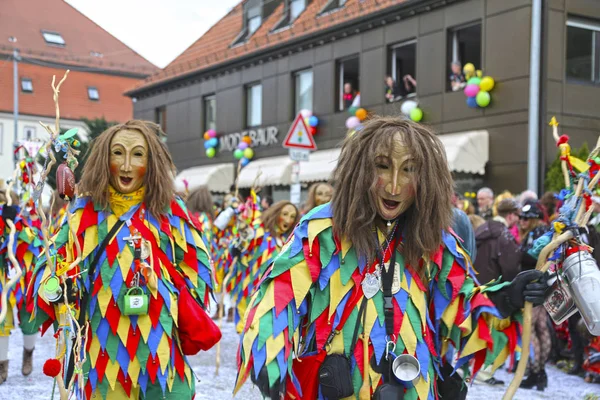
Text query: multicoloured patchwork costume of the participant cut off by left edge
0 205 43 336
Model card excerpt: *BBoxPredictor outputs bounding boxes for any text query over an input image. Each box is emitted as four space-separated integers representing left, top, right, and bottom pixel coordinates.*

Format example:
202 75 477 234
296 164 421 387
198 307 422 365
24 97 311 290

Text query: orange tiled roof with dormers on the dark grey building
132 0 407 92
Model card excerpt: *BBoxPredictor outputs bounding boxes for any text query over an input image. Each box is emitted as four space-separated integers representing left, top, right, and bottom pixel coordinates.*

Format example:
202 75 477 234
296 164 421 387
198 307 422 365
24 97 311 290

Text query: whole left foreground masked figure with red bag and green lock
28 120 220 400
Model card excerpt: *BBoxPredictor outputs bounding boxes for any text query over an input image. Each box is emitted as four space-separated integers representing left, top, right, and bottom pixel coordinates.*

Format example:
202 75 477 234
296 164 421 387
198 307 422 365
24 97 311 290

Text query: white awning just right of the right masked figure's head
438 130 490 175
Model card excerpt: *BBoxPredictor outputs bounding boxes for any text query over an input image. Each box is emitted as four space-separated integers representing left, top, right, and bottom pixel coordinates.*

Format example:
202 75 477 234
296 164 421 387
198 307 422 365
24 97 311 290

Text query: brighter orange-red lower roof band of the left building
0 61 139 122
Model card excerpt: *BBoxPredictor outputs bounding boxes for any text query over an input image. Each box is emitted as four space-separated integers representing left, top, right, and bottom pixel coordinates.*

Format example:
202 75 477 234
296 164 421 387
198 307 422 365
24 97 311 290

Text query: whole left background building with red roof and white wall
0 0 158 179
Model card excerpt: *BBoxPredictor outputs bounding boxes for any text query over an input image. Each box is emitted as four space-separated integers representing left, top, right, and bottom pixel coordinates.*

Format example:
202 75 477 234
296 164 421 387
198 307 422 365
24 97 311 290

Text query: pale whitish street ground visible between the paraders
0 323 600 400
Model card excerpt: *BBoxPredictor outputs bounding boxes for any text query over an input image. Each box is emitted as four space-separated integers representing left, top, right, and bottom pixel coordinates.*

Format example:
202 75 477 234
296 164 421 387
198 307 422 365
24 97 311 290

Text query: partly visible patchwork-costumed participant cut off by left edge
0 190 42 384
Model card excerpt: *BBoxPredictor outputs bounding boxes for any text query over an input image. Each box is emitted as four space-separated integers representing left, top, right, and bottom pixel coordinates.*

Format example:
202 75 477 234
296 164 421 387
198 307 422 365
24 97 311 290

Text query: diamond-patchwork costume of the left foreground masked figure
28 188 213 400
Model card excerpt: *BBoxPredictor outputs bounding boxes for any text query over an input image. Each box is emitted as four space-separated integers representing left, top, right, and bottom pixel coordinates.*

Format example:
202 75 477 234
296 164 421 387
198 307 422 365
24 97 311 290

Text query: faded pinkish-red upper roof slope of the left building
0 0 158 76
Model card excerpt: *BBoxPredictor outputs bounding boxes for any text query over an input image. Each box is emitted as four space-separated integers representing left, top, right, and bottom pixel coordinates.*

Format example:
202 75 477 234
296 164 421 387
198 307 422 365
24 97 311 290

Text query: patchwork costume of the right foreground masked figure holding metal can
236 204 519 400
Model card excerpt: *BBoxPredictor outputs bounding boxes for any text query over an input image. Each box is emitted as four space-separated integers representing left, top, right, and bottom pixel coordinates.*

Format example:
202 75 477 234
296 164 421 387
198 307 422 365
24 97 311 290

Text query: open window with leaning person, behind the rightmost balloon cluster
446 23 481 91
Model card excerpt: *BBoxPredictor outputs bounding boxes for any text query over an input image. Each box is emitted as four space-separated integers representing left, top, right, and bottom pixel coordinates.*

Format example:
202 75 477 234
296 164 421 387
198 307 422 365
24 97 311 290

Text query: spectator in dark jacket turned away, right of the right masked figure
473 199 521 386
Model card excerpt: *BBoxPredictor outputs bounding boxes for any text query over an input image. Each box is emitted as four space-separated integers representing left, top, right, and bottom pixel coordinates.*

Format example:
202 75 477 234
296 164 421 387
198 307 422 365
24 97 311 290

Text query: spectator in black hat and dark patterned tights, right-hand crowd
519 202 552 390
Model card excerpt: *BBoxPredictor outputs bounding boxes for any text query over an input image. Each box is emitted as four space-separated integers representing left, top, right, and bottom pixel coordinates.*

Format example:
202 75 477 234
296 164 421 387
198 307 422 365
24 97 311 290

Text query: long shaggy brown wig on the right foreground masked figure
331 117 453 266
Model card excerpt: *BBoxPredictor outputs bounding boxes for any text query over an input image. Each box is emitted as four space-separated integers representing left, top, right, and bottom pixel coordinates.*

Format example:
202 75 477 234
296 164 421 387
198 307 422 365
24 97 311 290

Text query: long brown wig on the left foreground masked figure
78 120 175 218
